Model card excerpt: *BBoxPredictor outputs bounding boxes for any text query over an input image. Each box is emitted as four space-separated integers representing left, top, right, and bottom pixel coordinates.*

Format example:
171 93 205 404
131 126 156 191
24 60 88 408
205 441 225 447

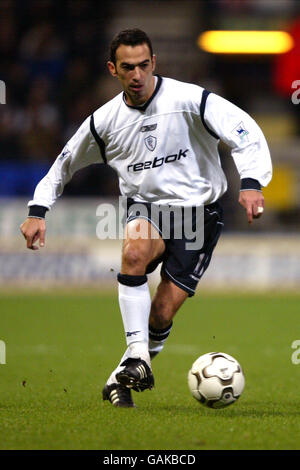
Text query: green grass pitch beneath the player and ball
0 291 300 450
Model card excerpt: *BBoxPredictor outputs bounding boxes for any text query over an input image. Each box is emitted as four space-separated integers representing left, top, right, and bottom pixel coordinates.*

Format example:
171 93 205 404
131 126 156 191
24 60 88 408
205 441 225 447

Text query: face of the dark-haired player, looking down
107 44 155 106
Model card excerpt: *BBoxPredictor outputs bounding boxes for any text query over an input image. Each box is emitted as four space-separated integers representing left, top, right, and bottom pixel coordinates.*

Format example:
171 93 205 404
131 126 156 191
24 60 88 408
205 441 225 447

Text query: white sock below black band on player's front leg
107 282 151 384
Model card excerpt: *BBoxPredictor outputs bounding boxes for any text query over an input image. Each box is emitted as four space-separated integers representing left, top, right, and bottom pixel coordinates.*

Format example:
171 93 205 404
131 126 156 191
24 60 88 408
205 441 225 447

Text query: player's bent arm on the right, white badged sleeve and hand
204 93 272 223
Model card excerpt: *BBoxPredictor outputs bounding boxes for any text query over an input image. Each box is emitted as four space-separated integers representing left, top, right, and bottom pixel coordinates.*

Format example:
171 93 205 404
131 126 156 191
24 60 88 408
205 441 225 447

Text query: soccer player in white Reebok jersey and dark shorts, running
21 29 272 407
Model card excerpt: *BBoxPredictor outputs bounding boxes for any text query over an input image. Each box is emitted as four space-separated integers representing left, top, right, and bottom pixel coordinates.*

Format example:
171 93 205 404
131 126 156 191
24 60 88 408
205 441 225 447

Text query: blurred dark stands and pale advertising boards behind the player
0 0 300 289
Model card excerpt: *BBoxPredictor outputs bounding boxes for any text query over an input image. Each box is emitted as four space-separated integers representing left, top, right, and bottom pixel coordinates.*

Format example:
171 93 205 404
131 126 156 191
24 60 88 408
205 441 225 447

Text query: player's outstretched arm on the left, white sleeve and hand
20 117 103 250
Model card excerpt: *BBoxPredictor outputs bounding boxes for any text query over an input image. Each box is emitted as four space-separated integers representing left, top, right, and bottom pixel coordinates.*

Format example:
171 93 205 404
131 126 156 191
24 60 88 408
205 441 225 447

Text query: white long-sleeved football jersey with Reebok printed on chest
28 76 272 209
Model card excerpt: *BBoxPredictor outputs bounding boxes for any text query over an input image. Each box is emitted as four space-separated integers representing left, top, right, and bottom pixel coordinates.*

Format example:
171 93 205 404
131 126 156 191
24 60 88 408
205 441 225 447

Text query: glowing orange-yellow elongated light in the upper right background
197 31 294 54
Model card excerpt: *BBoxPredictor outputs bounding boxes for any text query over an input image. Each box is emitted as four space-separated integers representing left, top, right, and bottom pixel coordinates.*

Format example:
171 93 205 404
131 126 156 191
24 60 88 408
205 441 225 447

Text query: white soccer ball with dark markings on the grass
188 352 245 408
